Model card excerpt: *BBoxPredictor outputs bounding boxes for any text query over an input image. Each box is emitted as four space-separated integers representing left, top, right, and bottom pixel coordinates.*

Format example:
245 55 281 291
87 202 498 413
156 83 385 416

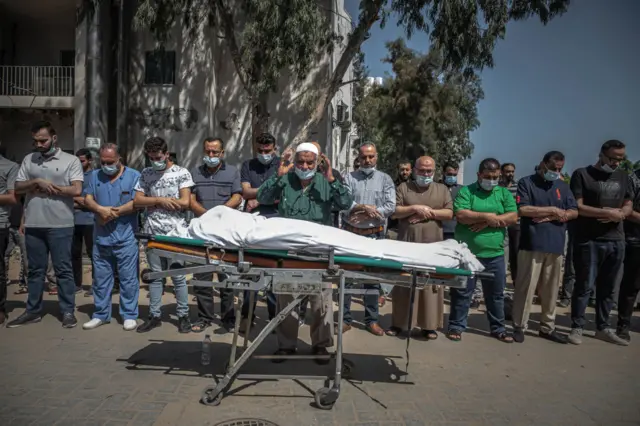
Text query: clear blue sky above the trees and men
345 0 640 183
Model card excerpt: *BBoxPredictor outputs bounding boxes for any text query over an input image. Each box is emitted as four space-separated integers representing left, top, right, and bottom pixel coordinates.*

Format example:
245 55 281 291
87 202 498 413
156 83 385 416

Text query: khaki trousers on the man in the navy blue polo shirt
513 250 562 333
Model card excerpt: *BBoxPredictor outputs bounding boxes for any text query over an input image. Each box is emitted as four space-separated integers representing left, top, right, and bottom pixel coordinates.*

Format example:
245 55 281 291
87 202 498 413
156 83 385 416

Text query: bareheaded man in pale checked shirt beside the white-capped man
341 143 396 336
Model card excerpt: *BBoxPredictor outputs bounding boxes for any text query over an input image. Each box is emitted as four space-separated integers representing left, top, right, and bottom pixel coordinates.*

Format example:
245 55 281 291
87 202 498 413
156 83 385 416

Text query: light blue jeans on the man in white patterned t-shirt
147 250 189 318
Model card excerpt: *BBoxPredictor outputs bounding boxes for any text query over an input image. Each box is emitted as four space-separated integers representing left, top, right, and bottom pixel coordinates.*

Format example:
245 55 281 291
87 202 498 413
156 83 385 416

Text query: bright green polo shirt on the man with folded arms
453 182 518 259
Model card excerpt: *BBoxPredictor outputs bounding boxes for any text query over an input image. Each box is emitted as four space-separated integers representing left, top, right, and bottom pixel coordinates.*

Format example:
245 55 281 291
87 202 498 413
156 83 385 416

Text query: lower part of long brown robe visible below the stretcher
391 286 444 330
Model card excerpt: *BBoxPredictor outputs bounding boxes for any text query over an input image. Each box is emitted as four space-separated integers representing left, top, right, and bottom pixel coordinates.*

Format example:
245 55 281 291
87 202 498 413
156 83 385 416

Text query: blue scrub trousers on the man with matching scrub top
92 241 138 321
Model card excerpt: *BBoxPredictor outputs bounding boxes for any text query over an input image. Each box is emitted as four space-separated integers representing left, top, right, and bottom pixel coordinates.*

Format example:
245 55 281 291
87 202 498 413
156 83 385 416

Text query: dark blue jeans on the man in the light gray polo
25 227 76 314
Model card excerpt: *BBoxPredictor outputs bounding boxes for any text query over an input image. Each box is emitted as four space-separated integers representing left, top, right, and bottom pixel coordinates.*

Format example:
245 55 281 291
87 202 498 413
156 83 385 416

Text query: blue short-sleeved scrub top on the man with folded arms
87 167 140 246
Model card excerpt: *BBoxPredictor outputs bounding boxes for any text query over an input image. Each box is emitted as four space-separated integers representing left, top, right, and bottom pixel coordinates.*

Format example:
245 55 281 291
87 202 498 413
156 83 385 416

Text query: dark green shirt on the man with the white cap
256 172 353 226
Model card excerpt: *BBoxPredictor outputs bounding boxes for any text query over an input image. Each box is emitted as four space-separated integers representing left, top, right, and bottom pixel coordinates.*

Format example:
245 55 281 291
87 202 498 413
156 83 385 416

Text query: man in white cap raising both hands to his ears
257 143 353 364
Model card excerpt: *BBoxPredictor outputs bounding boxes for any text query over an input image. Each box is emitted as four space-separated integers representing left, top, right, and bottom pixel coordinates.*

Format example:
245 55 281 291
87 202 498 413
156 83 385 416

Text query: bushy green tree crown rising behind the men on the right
354 39 483 171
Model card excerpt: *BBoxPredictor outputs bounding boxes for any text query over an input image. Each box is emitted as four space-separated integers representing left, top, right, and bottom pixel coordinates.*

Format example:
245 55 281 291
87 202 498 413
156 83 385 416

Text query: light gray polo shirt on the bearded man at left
16 149 84 228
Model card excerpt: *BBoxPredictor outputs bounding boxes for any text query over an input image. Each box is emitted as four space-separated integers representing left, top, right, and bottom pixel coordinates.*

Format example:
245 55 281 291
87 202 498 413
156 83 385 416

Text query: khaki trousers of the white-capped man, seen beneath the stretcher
276 289 333 349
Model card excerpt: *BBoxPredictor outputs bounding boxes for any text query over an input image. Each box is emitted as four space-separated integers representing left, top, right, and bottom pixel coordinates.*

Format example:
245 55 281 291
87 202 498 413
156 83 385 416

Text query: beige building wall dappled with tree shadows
128 0 351 171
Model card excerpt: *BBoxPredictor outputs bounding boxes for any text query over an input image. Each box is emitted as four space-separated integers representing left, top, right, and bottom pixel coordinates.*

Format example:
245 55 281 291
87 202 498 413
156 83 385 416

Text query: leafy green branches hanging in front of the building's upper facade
135 0 338 99
